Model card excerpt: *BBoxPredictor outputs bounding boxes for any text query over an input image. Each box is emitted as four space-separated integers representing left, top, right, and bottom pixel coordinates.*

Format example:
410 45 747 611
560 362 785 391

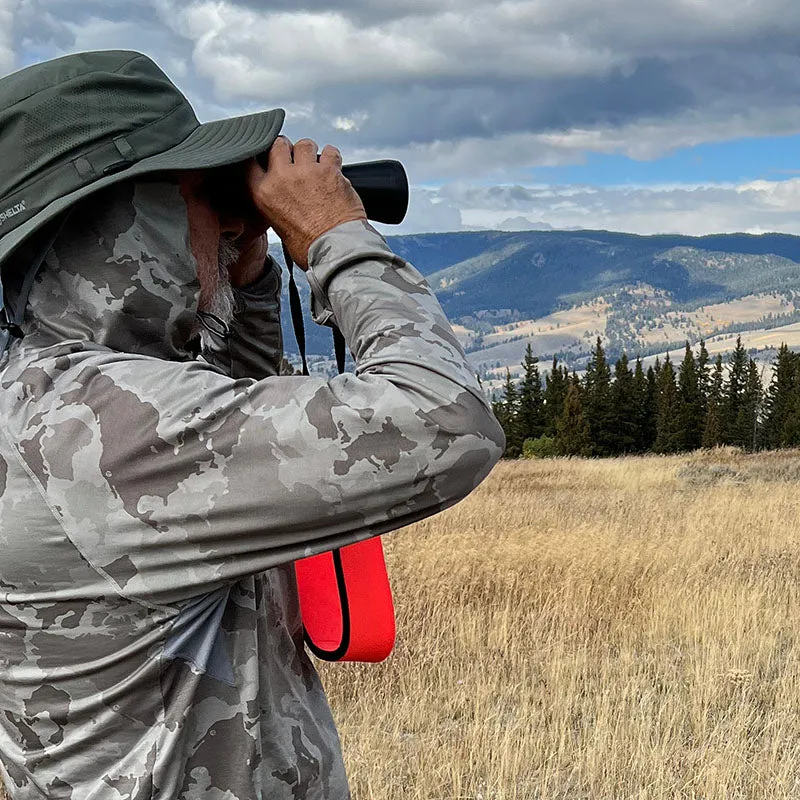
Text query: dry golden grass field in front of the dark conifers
323 451 800 800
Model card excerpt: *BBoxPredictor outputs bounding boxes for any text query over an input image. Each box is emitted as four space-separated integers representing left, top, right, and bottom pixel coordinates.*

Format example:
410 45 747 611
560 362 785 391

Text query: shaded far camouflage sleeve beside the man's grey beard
202 256 283 379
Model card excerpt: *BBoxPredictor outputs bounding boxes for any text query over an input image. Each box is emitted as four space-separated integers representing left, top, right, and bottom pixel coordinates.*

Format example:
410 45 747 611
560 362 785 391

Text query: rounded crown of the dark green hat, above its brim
0 50 199 227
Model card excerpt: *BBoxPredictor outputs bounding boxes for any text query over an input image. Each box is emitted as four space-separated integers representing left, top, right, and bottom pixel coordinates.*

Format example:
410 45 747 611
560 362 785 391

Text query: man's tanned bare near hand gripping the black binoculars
248 136 367 269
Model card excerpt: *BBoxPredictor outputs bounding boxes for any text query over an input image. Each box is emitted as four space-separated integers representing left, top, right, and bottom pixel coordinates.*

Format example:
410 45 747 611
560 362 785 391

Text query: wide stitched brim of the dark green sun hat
0 108 285 266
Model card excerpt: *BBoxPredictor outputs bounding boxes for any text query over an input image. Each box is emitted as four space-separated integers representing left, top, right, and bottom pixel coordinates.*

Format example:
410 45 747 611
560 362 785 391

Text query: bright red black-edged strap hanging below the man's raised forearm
295 536 395 662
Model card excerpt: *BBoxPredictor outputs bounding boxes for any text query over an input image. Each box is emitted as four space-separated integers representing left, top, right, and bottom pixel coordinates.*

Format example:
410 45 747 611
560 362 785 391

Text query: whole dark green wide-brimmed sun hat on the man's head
0 50 284 266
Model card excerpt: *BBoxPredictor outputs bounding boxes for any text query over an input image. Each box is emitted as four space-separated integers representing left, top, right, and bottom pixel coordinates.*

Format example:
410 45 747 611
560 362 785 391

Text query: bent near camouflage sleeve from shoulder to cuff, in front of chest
17 223 504 607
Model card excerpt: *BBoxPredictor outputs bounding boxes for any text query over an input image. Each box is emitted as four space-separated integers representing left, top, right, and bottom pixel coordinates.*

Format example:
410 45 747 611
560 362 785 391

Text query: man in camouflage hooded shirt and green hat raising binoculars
0 53 503 800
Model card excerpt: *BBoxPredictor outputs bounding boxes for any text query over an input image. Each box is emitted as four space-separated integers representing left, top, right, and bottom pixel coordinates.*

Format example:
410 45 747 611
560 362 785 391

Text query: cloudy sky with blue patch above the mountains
0 0 800 235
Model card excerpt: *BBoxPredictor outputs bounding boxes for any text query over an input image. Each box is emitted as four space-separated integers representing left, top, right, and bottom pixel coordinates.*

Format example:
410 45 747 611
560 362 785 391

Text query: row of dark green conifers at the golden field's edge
492 337 800 458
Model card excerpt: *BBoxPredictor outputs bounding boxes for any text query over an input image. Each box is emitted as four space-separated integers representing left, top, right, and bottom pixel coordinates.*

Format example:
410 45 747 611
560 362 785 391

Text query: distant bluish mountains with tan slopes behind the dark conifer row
284 231 800 377
